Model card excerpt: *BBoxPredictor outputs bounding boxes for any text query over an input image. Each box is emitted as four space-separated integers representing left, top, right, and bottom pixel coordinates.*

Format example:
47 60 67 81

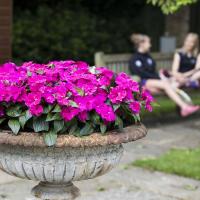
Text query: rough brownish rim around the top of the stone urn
0 124 147 148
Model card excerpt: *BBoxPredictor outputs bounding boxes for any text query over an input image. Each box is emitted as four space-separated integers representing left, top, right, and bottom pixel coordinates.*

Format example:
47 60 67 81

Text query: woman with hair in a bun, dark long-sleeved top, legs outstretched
129 34 199 117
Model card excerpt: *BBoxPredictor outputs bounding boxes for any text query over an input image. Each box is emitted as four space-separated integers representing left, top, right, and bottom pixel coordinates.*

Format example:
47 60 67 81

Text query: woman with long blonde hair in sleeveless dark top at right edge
172 33 200 88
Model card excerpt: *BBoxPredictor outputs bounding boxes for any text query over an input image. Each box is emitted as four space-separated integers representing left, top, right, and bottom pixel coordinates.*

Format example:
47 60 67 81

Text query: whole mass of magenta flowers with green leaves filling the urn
0 60 153 146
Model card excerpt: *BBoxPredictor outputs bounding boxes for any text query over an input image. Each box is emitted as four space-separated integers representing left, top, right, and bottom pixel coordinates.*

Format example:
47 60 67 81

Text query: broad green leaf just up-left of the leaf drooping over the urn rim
33 117 49 133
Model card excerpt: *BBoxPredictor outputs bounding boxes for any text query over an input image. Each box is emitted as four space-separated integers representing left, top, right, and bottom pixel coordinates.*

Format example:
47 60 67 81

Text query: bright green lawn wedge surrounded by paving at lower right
131 148 200 180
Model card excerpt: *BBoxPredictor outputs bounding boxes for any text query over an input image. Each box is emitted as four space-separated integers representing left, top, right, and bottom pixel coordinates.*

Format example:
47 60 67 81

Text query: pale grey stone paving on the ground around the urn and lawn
0 119 200 200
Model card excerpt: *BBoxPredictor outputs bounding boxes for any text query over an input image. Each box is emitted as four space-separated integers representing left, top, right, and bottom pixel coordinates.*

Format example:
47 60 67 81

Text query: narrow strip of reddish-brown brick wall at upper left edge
0 0 12 63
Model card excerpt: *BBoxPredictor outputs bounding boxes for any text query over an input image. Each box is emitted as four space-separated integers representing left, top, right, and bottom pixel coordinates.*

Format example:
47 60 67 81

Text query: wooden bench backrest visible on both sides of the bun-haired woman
95 52 173 74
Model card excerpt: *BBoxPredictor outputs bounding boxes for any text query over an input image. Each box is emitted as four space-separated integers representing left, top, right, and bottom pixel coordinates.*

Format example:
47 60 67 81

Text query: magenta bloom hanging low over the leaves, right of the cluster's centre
95 104 116 122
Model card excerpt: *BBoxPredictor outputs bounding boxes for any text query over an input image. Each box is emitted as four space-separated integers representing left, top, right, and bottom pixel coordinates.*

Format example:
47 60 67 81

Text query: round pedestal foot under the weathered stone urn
32 182 80 200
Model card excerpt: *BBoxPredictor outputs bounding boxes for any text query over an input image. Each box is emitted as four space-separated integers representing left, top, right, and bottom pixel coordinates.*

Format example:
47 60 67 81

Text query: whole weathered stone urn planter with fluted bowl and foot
0 125 147 200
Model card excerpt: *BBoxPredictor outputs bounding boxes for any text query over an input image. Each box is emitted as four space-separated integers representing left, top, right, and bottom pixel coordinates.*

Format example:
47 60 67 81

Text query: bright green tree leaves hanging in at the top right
147 0 198 14
